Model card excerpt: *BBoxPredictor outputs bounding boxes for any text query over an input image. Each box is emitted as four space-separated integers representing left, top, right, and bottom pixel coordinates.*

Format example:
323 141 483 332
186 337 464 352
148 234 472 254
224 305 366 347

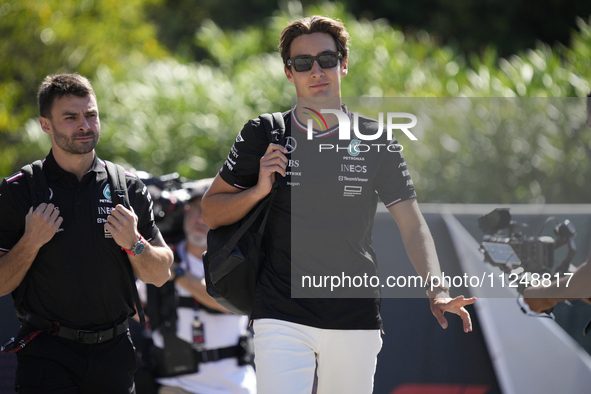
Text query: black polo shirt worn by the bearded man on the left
0 152 158 329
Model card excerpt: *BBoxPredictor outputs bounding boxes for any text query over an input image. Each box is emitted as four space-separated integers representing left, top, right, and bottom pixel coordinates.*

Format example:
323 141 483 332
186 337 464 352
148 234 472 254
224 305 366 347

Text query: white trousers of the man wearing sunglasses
253 319 382 394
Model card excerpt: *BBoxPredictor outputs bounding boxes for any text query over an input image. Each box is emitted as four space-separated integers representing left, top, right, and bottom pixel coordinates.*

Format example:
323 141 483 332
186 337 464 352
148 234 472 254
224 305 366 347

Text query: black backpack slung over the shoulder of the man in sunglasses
202 112 285 315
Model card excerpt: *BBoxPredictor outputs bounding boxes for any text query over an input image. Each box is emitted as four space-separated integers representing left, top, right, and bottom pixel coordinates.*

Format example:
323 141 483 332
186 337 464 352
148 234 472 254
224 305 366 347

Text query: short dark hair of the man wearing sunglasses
279 15 349 65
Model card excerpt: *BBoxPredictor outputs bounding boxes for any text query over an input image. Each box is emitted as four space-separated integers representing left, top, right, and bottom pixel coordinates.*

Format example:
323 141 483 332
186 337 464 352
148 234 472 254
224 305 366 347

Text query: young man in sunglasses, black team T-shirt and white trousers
203 16 475 394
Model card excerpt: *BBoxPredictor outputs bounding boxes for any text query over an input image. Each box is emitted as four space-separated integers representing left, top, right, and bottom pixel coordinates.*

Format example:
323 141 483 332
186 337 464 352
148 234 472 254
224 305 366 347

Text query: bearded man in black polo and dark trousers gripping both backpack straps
0 74 173 394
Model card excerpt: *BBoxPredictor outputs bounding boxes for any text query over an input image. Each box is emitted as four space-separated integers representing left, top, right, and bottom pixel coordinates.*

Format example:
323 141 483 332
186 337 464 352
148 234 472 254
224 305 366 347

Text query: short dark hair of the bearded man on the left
37 74 96 118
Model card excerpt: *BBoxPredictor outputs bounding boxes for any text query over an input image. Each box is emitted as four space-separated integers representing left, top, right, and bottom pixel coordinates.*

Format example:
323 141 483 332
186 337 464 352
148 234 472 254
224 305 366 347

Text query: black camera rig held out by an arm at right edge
478 208 577 292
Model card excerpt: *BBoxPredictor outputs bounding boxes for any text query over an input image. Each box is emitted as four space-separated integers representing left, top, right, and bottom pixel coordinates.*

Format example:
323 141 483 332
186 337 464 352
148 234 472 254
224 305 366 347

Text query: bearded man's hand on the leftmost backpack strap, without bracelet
23 203 64 249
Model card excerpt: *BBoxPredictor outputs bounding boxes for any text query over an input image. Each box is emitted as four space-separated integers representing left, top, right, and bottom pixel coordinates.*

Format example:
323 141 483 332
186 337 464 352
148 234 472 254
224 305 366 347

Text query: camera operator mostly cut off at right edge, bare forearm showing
523 93 591 313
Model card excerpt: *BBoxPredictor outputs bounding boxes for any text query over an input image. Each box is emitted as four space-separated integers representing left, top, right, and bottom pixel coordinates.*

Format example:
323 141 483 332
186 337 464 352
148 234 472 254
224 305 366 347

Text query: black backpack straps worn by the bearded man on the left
14 160 145 324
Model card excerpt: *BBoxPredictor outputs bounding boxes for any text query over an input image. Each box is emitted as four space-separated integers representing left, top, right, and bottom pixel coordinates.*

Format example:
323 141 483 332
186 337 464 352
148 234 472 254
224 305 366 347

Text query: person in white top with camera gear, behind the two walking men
138 178 256 394
